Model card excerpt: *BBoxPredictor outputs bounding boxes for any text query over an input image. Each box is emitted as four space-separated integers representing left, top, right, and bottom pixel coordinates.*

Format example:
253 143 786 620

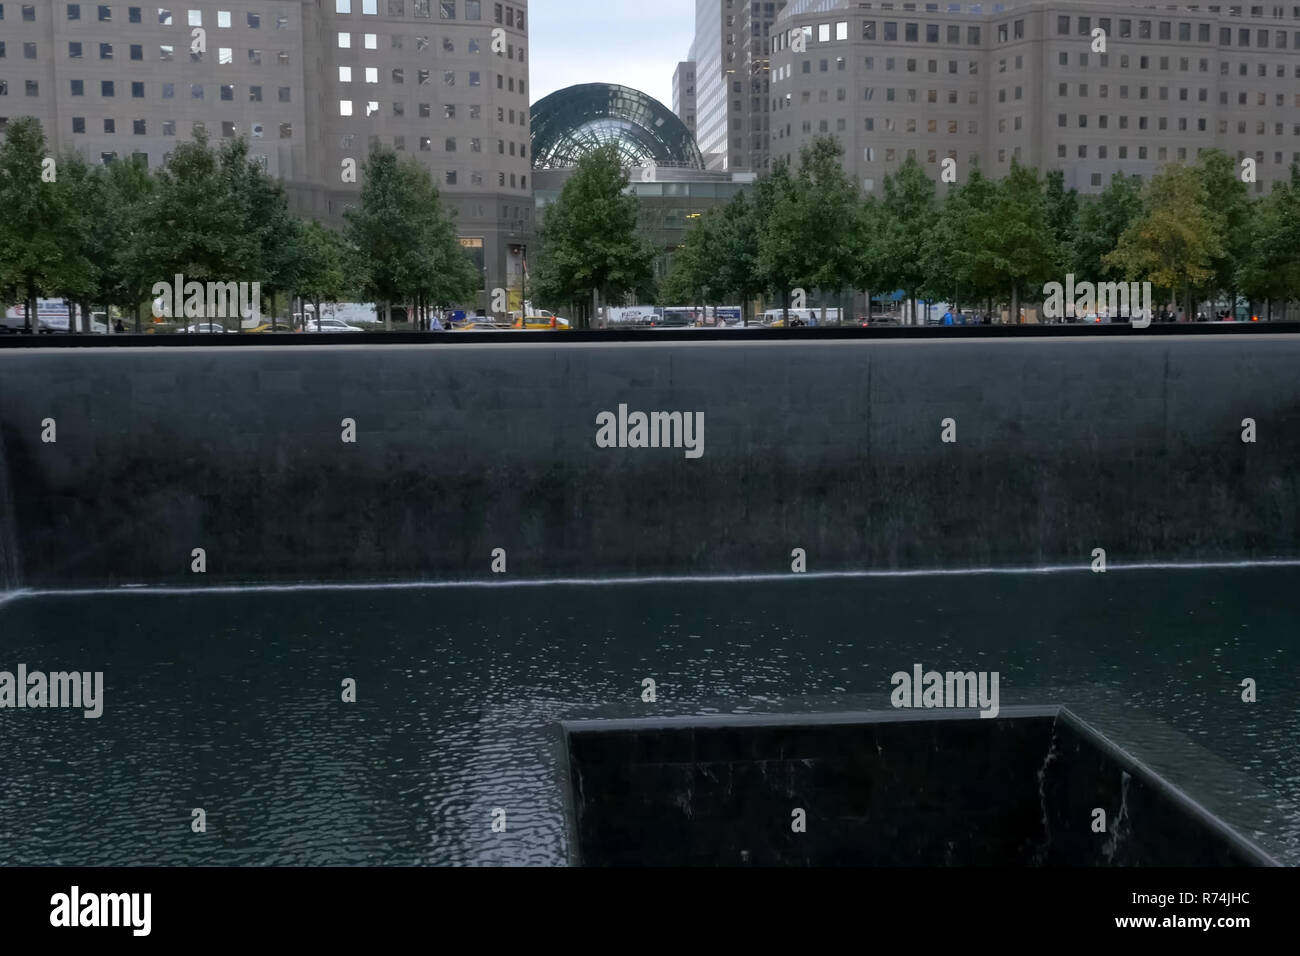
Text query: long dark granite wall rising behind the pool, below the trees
0 336 1300 587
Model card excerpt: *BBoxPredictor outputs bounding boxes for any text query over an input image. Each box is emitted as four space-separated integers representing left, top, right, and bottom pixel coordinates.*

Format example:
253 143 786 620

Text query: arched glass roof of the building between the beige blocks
532 83 705 169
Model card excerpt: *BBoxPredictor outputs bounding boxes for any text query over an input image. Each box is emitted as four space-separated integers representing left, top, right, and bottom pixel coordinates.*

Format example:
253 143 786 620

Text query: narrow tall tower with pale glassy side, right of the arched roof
692 0 785 170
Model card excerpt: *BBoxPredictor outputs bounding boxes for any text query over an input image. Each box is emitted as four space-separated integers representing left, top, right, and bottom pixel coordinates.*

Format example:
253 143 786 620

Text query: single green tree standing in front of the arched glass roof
533 146 655 328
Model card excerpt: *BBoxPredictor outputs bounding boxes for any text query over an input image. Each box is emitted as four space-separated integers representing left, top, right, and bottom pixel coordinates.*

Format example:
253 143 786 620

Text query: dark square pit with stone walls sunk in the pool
562 708 1271 866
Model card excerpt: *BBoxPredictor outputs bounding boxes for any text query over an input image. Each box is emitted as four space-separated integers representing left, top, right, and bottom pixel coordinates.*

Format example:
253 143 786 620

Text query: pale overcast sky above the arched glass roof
528 0 696 109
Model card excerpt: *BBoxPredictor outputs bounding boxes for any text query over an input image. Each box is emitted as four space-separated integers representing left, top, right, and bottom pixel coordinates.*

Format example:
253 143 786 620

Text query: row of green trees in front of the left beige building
0 118 481 330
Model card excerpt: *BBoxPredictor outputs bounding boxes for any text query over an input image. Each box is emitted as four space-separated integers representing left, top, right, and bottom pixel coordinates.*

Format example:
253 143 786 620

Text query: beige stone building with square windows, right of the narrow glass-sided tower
770 0 1300 193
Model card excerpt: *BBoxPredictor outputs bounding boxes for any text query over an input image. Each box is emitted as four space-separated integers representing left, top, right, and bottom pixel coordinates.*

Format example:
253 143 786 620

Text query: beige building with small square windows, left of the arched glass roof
0 0 532 306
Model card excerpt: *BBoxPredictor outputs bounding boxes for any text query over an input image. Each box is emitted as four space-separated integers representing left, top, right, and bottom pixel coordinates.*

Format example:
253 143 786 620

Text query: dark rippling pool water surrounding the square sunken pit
0 568 1300 865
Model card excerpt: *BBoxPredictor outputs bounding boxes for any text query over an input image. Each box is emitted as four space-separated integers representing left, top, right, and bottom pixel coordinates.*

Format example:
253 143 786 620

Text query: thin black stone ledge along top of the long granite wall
0 321 1300 349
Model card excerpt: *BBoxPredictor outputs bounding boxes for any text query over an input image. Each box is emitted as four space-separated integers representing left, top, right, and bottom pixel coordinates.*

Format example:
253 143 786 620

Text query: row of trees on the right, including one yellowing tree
650 138 1300 323
